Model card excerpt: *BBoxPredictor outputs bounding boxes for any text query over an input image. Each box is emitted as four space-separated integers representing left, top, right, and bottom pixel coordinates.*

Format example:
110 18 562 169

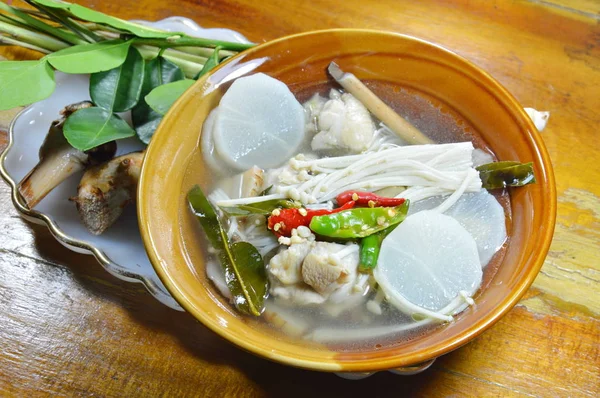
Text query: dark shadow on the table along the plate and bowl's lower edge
31 225 464 397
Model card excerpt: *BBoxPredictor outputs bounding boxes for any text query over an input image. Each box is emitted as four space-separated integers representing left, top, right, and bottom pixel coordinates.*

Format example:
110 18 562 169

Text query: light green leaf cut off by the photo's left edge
0 59 56 110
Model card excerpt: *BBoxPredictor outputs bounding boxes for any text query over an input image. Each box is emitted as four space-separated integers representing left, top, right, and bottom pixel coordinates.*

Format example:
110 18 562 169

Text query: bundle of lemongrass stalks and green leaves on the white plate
0 0 252 151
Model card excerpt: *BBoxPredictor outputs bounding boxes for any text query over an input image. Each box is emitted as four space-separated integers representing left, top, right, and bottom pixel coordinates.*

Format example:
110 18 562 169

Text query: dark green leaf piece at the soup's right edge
477 161 535 189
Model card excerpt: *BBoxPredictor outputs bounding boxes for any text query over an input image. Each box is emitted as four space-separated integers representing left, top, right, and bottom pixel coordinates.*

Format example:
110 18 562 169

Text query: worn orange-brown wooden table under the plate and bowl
0 0 600 397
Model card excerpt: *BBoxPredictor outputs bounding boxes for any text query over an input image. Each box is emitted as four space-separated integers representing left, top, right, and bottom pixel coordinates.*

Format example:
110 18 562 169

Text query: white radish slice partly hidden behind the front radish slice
408 189 506 267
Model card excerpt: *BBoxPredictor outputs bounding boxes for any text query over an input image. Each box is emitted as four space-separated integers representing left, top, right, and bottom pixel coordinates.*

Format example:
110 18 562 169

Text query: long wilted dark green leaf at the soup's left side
188 186 269 316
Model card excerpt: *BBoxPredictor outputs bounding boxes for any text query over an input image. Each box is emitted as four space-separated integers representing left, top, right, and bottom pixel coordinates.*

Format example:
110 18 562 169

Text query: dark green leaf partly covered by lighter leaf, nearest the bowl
131 56 185 144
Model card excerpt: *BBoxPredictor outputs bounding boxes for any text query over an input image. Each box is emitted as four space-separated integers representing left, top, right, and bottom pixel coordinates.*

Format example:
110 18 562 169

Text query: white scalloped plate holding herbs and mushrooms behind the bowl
0 17 249 311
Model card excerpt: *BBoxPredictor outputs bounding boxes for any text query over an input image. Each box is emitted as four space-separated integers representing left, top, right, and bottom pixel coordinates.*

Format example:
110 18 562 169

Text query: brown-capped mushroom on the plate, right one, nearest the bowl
70 152 144 235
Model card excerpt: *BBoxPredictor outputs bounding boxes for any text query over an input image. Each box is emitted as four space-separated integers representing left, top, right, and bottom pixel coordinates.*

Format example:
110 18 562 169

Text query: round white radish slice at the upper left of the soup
213 73 304 170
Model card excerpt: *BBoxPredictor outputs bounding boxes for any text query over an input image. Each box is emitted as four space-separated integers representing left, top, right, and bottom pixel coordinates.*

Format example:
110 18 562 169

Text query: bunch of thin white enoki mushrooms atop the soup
270 142 481 204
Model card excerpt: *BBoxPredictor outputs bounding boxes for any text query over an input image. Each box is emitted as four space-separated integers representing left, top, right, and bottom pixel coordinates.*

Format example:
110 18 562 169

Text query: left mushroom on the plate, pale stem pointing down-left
19 101 117 209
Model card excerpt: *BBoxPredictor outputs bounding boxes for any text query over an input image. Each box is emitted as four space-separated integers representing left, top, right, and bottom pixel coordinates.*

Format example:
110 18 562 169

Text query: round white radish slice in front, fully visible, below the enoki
373 210 483 321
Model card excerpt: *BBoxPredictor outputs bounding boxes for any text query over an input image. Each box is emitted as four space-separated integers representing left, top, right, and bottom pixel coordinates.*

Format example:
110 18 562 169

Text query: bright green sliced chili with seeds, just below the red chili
310 200 408 239
